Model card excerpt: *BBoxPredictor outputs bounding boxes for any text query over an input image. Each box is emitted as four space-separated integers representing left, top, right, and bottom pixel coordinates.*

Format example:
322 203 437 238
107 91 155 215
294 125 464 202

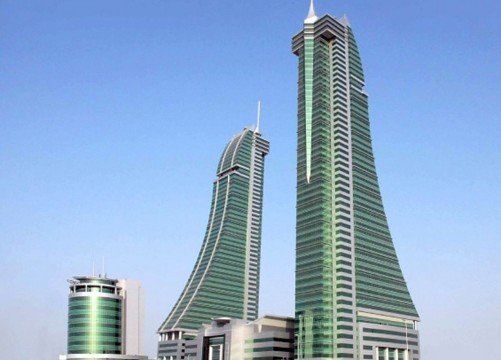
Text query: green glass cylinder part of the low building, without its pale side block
68 276 124 354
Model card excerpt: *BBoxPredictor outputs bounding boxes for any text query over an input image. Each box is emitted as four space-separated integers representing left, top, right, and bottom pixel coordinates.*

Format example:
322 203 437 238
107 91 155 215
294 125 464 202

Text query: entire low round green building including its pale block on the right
60 276 147 360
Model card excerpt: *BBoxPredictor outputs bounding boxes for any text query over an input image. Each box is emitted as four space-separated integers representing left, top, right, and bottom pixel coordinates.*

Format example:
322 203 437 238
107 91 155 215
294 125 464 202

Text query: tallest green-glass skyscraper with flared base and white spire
292 1 420 360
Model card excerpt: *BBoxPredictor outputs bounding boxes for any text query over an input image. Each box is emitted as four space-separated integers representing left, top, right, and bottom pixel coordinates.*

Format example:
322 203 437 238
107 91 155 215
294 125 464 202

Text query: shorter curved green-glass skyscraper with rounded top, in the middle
158 128 269 359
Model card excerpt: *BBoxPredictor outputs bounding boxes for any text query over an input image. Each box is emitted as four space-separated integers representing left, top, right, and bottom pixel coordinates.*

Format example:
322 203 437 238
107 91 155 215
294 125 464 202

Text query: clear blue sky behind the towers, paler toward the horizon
0 0 501 360
